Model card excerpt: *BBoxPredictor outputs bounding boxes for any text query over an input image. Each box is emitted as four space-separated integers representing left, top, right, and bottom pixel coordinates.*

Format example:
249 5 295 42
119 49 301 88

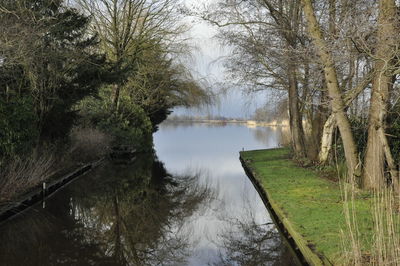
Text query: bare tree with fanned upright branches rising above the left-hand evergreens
77 0 186 112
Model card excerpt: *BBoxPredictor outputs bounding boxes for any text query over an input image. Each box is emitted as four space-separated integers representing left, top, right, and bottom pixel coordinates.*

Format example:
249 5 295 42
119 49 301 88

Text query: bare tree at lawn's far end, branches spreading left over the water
202 0 308 157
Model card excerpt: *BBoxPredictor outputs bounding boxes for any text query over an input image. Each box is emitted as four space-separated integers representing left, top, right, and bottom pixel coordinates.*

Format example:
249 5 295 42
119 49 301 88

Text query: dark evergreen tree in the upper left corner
0 0 105 154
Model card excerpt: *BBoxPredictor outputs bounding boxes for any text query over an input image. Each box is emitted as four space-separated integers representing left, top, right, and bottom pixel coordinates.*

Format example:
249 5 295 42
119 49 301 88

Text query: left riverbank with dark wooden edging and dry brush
0 143 142 224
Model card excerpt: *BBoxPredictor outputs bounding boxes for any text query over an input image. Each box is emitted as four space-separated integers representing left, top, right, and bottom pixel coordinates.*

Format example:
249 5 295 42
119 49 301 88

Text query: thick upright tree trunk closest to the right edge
363 0 398 189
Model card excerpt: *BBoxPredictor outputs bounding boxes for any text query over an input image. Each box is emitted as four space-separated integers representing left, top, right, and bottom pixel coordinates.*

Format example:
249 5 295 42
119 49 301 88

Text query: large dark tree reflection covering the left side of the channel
0 154 211 265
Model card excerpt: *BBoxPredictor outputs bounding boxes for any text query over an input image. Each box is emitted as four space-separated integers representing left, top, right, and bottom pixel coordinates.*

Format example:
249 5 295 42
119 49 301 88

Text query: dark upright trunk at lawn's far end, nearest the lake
288 59 306 158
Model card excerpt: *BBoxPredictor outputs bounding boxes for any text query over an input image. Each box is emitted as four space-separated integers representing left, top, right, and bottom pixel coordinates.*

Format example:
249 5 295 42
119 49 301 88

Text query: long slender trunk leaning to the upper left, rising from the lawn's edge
302 0 360 181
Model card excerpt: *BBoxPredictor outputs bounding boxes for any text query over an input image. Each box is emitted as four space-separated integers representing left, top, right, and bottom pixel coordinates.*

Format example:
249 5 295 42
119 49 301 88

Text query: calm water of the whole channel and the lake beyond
0 124 294 265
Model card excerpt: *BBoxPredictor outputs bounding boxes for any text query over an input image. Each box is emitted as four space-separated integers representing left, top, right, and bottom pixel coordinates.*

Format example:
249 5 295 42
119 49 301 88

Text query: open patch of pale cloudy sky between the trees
174 0 266 118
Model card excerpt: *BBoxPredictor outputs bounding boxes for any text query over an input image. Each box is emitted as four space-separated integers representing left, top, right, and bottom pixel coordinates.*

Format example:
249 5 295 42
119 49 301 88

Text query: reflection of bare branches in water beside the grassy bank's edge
211 189 298 266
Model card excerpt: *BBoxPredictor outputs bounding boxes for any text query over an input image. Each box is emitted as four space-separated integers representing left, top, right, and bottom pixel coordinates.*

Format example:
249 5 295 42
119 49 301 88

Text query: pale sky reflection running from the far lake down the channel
154 124 286 265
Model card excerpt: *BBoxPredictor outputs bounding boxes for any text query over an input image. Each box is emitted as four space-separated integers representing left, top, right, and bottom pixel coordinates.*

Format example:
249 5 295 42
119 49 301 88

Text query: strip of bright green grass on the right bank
241 149 373 264
